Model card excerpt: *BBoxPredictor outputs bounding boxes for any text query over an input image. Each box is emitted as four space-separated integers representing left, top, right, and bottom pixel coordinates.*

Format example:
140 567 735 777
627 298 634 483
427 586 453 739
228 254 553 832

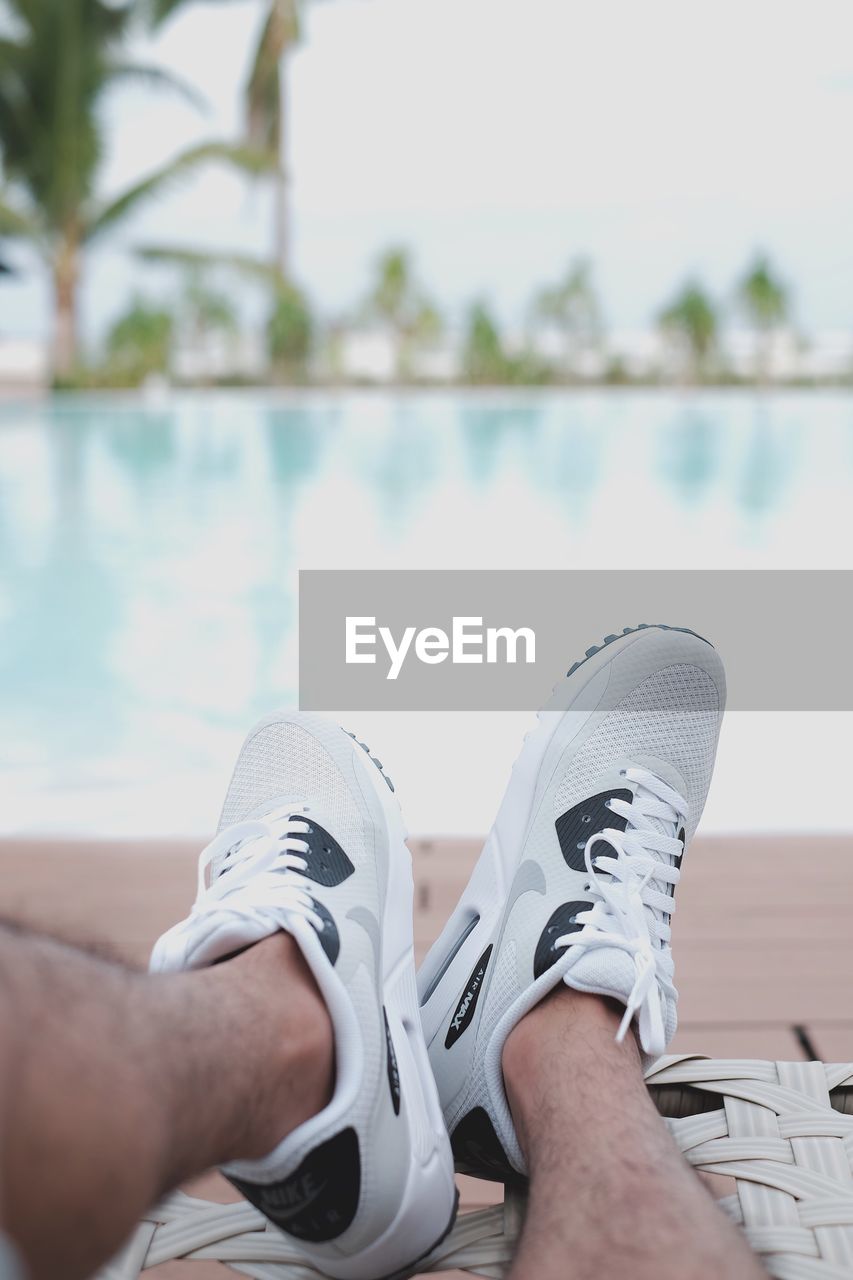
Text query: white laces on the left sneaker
151 808 323 961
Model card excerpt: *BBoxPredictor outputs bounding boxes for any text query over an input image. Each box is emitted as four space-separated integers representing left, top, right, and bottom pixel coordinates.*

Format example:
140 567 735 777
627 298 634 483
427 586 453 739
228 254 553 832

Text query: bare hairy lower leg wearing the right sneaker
503 987 766 1280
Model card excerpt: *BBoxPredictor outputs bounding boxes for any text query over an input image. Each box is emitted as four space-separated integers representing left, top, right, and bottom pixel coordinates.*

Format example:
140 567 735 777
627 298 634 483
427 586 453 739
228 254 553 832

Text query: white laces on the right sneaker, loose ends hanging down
556 768 688 1057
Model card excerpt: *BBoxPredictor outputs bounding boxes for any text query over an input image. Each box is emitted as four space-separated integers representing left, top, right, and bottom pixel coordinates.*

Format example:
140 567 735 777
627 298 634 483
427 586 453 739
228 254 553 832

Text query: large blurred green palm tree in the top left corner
0 0 269 379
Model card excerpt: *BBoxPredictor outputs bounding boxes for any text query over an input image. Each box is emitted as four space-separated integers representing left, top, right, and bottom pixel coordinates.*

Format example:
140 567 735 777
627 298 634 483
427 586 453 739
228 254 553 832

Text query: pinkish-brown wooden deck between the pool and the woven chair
0 836 853 1280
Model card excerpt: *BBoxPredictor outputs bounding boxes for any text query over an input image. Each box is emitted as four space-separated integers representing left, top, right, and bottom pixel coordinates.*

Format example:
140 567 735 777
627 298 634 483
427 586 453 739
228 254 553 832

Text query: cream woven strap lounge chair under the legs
101 1056 853 1280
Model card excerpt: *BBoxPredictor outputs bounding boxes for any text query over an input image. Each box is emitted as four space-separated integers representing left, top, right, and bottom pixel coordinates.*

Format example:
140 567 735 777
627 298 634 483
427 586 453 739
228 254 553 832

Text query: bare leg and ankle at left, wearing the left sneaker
0 925 333 1280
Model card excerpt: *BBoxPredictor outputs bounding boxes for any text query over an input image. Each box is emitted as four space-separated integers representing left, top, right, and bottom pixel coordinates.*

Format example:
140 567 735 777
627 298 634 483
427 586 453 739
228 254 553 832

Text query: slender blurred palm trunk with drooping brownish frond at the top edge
149 0 304 279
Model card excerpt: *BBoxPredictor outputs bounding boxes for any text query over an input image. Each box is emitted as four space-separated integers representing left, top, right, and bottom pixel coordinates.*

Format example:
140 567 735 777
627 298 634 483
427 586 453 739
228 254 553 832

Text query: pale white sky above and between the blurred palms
0 0 853 335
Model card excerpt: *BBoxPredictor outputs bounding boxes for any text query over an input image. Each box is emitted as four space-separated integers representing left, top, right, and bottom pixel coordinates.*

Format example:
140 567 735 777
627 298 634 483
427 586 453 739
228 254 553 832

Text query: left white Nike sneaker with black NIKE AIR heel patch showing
151 714 456 1280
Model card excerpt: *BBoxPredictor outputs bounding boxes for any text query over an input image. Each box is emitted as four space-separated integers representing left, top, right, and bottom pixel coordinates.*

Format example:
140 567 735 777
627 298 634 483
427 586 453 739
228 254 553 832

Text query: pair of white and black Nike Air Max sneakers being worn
151 626 725 1280
